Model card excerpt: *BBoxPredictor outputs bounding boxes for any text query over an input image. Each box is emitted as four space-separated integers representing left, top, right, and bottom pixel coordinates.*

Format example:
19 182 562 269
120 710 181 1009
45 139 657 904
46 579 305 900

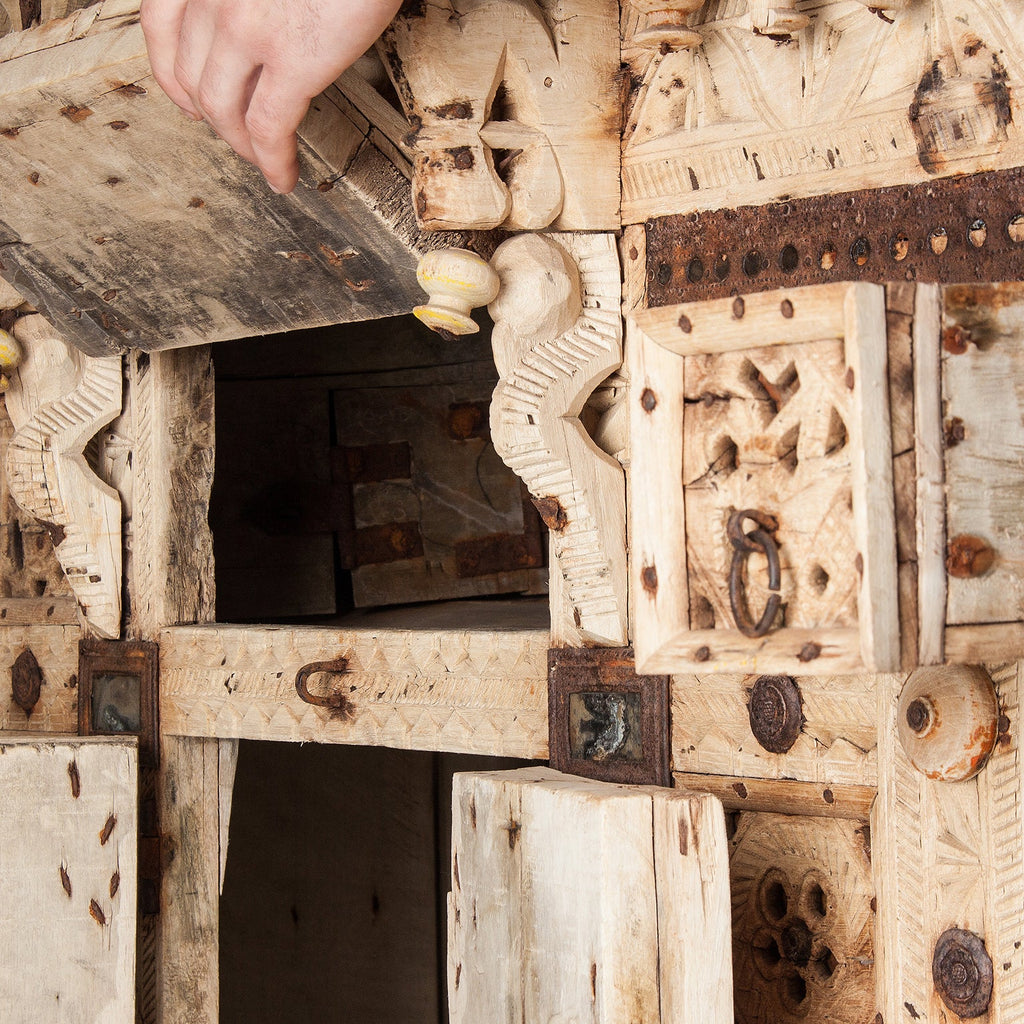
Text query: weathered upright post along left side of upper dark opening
123 347 215 640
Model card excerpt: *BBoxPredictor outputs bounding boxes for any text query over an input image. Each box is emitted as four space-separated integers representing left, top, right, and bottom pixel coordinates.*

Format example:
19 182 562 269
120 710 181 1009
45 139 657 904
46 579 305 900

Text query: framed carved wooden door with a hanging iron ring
629 285 899 674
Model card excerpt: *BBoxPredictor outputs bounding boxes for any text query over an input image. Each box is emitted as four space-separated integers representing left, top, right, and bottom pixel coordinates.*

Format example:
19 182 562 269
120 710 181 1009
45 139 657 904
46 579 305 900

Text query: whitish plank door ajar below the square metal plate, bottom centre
447 768 733 1024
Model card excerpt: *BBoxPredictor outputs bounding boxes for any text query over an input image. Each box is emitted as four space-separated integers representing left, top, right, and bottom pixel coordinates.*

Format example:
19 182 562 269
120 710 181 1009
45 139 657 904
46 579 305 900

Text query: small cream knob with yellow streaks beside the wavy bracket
413 249 499 335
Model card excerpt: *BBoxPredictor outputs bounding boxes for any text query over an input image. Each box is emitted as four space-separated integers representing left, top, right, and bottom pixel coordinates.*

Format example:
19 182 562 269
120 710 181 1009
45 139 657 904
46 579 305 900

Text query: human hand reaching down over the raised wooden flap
141 0 400 193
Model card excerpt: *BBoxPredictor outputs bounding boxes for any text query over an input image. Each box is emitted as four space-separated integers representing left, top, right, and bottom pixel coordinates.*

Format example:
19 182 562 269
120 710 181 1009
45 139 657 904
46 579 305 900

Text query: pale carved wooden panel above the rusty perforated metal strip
623 0 1024 223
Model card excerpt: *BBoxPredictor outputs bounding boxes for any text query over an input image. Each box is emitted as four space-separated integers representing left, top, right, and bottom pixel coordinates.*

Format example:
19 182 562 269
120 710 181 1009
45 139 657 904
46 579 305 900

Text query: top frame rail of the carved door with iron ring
632 284 847 355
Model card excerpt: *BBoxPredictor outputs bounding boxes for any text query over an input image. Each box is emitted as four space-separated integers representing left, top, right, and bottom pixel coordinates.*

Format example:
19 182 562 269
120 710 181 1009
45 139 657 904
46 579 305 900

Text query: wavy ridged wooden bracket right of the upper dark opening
488 234 627 646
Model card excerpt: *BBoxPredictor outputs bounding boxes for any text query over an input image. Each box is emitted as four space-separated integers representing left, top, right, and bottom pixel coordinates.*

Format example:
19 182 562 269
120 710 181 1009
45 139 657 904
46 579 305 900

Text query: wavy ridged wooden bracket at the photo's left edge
6 313 121 638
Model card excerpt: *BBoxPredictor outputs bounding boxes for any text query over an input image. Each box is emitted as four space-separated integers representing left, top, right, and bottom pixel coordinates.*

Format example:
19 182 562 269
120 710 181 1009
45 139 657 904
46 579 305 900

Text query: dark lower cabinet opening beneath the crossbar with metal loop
220 741 530 1024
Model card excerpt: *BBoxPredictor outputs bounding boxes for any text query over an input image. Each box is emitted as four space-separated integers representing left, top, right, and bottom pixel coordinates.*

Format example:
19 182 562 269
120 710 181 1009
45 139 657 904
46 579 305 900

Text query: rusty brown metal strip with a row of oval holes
646 167 1024 306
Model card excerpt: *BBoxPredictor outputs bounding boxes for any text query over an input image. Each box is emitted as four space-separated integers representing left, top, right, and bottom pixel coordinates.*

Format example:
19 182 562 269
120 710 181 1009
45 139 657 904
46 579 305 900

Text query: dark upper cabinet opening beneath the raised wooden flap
210 310 548 628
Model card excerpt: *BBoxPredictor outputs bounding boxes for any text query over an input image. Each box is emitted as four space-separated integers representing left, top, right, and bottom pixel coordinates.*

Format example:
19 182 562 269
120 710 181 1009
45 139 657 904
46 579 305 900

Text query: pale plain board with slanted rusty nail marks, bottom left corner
0 737 137 1024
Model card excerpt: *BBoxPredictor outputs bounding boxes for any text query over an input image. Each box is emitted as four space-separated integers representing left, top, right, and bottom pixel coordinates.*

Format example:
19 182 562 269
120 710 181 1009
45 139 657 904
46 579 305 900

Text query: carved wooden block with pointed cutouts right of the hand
381 0 621 230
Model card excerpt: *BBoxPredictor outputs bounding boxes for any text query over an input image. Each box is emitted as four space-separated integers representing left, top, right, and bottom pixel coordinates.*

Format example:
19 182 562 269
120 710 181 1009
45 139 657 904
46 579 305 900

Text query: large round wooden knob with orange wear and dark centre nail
897 666 999 782
